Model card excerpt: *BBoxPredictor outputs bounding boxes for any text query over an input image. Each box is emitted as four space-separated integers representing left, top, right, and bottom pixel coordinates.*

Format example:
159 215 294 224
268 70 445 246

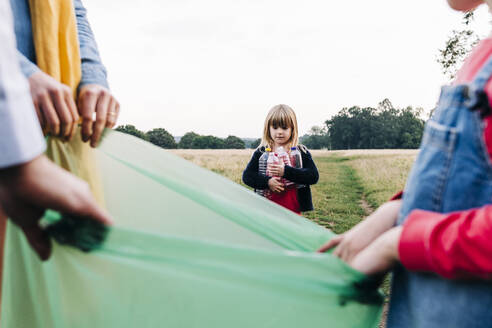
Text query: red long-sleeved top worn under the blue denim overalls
400 38 492 279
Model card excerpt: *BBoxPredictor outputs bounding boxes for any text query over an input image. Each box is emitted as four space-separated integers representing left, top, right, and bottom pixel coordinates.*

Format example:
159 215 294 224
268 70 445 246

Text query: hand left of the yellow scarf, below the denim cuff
28 71 79 140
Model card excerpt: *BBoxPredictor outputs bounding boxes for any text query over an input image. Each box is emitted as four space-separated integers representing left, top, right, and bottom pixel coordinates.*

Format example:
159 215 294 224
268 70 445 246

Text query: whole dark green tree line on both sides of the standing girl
116 99 424 150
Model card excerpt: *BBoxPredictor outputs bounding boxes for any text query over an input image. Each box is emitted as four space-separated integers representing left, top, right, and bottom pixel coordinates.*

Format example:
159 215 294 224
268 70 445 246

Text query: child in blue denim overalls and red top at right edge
320 0 492 328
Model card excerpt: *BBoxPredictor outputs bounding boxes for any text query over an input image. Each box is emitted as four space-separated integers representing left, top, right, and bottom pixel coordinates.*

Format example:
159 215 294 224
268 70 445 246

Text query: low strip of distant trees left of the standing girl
115 125 246 149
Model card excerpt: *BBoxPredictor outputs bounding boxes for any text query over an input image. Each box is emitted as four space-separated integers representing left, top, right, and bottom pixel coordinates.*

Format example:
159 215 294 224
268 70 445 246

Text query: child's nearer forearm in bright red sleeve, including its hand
349 205 492 280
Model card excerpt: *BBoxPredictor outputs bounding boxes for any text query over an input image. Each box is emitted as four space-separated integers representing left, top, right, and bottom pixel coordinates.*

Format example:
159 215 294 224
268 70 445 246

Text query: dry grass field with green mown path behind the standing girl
173 149 417 327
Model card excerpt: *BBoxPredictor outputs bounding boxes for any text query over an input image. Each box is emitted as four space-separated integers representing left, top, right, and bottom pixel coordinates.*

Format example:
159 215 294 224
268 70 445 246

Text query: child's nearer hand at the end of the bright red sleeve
349 226 403 275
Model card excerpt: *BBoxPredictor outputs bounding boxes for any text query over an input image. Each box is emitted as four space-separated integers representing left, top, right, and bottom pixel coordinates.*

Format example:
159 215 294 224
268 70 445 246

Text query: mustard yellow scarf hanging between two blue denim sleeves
29 0 104 205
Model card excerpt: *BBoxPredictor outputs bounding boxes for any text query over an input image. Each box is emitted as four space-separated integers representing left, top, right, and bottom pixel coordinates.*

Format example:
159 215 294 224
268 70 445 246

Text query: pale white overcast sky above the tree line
84 0 490 137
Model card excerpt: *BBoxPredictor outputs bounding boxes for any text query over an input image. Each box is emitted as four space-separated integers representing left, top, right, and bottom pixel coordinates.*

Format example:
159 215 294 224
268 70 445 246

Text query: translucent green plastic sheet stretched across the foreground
1 132 381 328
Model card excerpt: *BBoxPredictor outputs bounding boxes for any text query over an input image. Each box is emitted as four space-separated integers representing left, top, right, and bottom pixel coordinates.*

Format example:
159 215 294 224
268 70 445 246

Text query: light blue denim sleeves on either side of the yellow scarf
10 0 108 88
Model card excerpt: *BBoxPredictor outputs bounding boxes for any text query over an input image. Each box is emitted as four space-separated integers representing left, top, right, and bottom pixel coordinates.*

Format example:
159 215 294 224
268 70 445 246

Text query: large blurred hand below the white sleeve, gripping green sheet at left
0 156 112 261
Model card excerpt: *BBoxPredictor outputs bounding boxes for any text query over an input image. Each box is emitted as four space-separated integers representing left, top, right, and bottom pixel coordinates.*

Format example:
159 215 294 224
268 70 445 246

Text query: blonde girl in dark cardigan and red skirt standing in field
243 105 319 214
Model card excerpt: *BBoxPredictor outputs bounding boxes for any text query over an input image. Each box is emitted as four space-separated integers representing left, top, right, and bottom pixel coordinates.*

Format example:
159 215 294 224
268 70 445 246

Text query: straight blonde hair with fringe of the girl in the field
259 104 299 151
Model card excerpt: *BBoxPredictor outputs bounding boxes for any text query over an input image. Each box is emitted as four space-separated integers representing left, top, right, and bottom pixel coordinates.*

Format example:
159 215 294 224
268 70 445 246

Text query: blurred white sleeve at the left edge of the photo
0 0 46 169
